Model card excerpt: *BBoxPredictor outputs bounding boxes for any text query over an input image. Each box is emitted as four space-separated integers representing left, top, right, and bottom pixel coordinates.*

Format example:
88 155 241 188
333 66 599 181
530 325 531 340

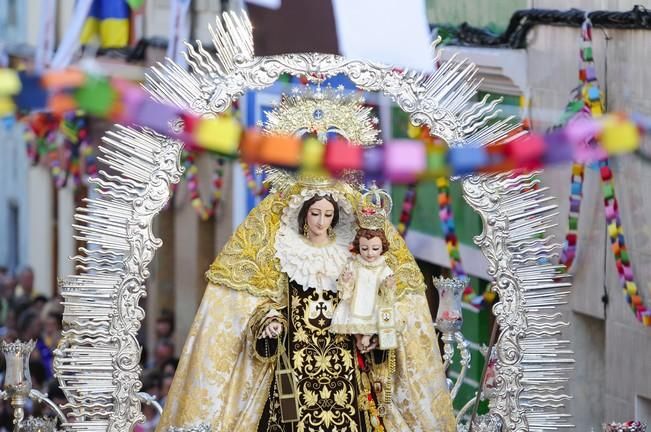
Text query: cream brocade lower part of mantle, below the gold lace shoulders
157 284 456 432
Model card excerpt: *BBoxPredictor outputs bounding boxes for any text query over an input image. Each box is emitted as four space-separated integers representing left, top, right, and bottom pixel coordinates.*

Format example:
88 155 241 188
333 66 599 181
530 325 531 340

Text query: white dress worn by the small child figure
330 255 393 334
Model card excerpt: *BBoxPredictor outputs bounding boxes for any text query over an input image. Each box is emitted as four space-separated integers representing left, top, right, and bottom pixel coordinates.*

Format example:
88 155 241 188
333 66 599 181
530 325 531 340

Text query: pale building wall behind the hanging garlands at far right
527 0 651 430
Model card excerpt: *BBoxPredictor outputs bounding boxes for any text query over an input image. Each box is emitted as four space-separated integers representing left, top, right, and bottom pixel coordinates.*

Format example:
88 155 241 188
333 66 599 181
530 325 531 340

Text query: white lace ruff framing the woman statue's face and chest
275 190 355 292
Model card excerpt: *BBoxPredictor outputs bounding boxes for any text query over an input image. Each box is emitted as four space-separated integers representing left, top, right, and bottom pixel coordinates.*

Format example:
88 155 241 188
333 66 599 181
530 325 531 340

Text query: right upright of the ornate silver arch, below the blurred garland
463 173 574 432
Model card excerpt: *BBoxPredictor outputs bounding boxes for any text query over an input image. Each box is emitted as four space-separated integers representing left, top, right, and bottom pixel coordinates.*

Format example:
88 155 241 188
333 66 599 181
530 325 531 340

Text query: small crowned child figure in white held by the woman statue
330 202 396 352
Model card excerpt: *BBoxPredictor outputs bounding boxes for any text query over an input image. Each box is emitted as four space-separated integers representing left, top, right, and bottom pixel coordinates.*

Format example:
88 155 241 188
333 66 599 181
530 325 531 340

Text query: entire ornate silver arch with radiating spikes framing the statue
54 13 569 431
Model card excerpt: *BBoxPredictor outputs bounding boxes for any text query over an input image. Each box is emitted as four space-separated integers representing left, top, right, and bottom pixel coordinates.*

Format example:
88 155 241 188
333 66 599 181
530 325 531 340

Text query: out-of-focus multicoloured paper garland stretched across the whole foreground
0 69 651 183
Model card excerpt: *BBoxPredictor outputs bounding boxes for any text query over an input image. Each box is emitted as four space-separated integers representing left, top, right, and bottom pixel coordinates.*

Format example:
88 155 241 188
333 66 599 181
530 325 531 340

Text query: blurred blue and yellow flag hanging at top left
81 0 131 48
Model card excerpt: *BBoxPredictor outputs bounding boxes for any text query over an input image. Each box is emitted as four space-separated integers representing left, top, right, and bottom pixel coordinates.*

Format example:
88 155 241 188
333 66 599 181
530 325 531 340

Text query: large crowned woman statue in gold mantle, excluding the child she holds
158 90 456 432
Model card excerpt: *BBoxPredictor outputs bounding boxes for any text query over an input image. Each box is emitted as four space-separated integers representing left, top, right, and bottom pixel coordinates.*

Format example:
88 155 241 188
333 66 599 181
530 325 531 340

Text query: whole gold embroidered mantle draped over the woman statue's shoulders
157 187 456 432
